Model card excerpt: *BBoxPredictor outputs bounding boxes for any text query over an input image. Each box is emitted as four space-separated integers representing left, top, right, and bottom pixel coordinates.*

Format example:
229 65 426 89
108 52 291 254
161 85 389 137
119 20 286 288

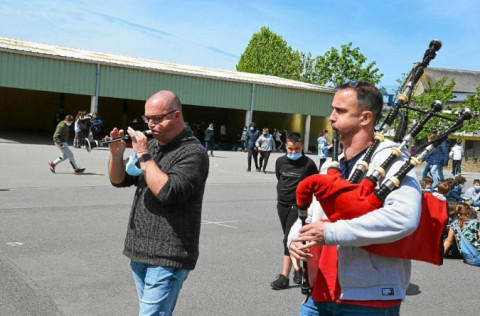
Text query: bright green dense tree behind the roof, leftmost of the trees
237 27 302 80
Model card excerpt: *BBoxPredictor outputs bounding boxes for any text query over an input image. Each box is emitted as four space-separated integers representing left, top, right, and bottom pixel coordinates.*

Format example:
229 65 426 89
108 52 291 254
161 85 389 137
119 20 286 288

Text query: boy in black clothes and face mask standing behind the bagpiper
270 132 318 290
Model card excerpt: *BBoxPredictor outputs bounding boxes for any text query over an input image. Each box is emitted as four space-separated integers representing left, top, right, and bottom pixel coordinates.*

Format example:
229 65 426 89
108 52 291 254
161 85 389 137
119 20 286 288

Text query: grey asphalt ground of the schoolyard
0 133 480 316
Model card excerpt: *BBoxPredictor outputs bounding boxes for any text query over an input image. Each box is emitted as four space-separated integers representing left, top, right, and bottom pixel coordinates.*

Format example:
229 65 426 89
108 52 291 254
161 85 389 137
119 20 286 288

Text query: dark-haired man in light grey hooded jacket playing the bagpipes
289 82 422 315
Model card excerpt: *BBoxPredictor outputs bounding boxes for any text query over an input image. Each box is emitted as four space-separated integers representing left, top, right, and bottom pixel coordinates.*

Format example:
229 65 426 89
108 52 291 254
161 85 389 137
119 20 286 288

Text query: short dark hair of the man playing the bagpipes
337 81 383 122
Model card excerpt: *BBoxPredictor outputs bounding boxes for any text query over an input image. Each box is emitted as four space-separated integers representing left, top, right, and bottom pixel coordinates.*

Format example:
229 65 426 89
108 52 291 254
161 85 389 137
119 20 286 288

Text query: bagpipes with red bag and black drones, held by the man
297 41 471 295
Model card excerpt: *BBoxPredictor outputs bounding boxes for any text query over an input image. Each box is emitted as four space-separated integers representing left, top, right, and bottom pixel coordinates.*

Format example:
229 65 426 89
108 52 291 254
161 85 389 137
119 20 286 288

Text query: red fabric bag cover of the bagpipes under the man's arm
297 168 447 265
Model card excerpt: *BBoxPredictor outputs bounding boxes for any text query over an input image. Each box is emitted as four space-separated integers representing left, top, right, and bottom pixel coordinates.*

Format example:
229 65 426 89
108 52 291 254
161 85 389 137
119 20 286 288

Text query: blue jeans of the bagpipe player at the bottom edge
299 296 400 316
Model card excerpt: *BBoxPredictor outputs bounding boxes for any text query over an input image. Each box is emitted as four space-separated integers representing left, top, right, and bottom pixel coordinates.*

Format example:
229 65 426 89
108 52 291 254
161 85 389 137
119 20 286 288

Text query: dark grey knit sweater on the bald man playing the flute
115 127 209 270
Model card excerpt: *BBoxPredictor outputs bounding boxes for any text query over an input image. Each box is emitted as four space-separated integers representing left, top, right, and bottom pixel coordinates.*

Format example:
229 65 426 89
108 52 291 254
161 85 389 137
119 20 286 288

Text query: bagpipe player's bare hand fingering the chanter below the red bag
289 221 325 261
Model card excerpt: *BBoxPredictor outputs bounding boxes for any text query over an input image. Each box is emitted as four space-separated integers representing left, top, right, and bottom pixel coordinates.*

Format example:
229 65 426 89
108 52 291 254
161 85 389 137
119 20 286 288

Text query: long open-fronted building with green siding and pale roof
0 37 334 148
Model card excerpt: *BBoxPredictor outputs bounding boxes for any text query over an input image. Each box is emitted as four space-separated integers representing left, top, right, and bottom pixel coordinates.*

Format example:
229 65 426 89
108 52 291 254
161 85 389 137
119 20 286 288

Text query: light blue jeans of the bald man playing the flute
130 261 189 316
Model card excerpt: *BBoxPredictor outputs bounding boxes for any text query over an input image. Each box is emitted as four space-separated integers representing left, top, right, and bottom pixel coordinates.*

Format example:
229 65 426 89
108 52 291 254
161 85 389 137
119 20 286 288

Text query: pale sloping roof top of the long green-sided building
0 37 334 93
